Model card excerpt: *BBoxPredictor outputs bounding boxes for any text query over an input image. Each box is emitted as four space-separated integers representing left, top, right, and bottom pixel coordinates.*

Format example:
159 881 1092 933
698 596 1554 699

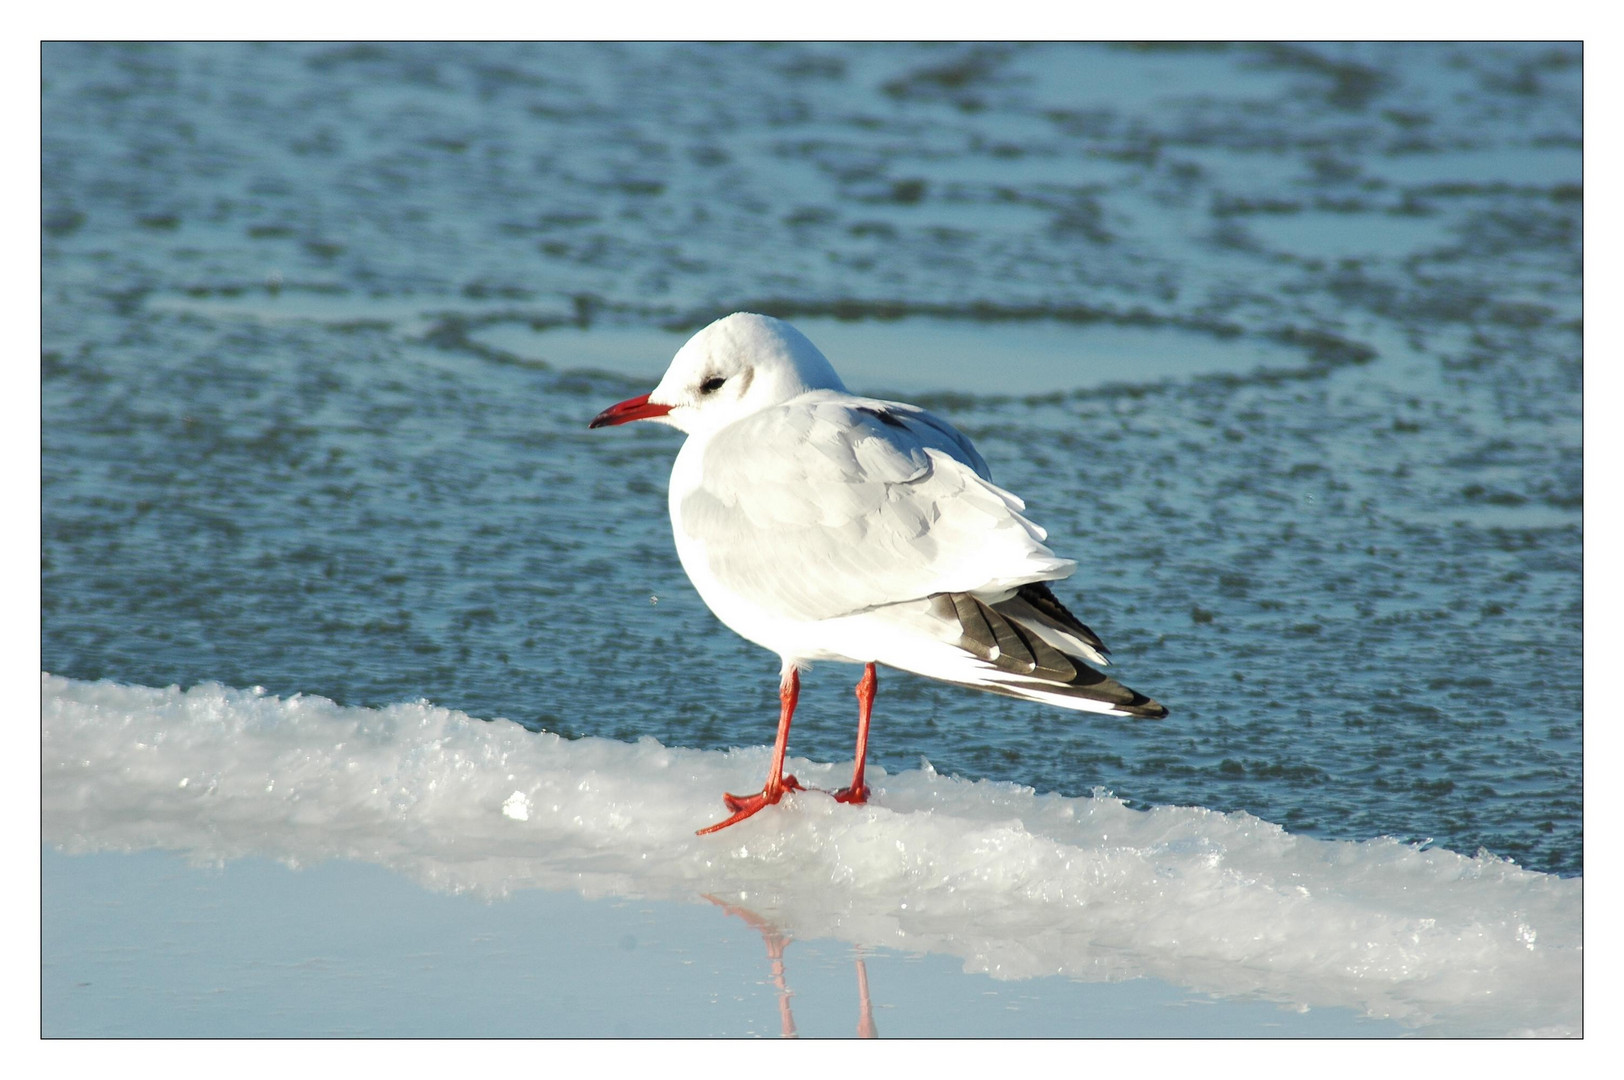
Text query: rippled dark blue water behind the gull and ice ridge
41 44 1583 875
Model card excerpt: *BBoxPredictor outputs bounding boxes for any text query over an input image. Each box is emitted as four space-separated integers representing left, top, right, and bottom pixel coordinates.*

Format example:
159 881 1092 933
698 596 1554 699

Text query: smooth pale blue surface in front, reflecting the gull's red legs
42 848 1403 1046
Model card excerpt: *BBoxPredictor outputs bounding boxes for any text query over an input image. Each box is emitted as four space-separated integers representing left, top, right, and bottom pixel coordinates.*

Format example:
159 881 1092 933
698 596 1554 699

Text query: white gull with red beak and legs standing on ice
590 312 1168 835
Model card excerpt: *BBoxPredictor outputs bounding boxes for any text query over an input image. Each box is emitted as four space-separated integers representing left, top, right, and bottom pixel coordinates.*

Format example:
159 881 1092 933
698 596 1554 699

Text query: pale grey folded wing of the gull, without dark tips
679 395 1075 620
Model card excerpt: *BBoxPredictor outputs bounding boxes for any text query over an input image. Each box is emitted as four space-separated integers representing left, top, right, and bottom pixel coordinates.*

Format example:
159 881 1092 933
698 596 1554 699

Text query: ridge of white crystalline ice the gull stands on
42 674 1583 1035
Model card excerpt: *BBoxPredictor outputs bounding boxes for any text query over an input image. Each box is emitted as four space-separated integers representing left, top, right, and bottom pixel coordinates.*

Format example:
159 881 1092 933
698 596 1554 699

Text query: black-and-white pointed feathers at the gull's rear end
931 586 1168 719
